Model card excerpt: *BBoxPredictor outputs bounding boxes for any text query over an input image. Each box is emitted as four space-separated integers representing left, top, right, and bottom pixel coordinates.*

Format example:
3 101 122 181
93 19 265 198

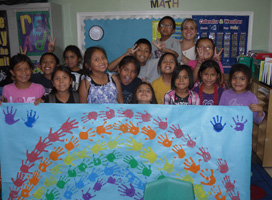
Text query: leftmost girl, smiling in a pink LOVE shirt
3 54 45 103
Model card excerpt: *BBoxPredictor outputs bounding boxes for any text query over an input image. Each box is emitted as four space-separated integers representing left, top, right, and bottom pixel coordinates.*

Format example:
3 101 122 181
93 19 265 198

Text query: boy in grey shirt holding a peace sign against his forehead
108 38 160 83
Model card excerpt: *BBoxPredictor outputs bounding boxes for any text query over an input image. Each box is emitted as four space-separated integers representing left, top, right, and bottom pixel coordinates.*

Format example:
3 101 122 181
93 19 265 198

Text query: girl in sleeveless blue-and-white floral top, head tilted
79 47 123 104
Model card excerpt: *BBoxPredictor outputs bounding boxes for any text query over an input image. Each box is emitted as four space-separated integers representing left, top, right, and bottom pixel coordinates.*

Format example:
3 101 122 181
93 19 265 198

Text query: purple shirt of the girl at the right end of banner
219 89 265 124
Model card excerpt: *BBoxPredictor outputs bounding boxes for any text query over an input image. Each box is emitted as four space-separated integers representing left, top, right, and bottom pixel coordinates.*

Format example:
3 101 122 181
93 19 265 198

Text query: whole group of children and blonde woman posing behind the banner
0 16 264 123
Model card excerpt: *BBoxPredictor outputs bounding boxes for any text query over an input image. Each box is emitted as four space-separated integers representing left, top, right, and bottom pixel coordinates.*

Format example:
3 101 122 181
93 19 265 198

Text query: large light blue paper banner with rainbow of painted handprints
0 103 252 200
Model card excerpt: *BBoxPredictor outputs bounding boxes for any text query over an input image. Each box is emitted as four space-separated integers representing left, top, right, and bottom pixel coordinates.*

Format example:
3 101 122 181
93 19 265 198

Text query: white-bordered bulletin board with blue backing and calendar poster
77 11 253 69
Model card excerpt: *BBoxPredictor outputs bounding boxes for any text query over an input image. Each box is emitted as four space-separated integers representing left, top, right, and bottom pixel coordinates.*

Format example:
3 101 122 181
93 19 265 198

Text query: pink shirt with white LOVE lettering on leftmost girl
3 83 45 103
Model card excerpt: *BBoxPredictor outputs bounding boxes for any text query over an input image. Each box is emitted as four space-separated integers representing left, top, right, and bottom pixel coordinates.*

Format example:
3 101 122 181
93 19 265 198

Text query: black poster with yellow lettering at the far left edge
0 10 11 86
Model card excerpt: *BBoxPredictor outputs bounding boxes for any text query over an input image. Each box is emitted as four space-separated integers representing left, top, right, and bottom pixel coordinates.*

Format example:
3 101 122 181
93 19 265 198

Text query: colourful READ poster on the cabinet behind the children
16 11 51 56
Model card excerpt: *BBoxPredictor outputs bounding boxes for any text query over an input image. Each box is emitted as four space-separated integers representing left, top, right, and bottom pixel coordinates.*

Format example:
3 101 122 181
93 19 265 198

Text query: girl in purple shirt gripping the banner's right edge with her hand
219 64 265 124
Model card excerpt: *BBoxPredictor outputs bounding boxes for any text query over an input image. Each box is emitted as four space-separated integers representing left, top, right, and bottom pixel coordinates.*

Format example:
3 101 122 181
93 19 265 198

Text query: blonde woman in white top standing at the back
180 18 197 63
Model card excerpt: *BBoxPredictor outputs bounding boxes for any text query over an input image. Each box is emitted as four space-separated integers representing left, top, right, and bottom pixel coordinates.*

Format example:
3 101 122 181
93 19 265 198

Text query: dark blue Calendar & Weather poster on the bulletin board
192 15 249 73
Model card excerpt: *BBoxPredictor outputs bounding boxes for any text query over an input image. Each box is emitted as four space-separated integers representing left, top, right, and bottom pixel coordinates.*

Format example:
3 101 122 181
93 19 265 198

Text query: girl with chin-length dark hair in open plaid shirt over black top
164 65 200 105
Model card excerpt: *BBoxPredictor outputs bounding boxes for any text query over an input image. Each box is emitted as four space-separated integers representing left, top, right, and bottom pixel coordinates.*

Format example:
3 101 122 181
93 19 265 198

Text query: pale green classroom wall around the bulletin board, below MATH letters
48 0 271 50
